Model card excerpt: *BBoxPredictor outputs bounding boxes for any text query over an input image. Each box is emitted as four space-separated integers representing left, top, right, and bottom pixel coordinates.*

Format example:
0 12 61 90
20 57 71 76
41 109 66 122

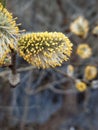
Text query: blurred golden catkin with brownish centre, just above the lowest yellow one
84 65 97 80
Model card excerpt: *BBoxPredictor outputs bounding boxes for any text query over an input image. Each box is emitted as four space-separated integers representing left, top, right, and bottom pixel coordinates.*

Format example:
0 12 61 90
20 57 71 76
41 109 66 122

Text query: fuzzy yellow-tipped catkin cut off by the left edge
0 3 19 66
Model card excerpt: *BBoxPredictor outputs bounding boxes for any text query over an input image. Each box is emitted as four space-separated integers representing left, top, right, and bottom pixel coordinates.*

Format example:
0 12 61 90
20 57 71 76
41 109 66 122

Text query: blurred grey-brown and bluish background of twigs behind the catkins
0 0 98 130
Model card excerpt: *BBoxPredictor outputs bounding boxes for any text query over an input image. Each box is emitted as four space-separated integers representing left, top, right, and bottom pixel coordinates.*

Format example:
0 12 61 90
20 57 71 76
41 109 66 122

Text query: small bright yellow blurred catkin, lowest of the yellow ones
75 81 87 92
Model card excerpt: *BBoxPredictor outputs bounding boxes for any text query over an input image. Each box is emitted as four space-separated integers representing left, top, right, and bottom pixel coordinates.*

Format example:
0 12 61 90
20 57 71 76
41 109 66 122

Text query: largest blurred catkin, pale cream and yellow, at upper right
70 16 89 38
